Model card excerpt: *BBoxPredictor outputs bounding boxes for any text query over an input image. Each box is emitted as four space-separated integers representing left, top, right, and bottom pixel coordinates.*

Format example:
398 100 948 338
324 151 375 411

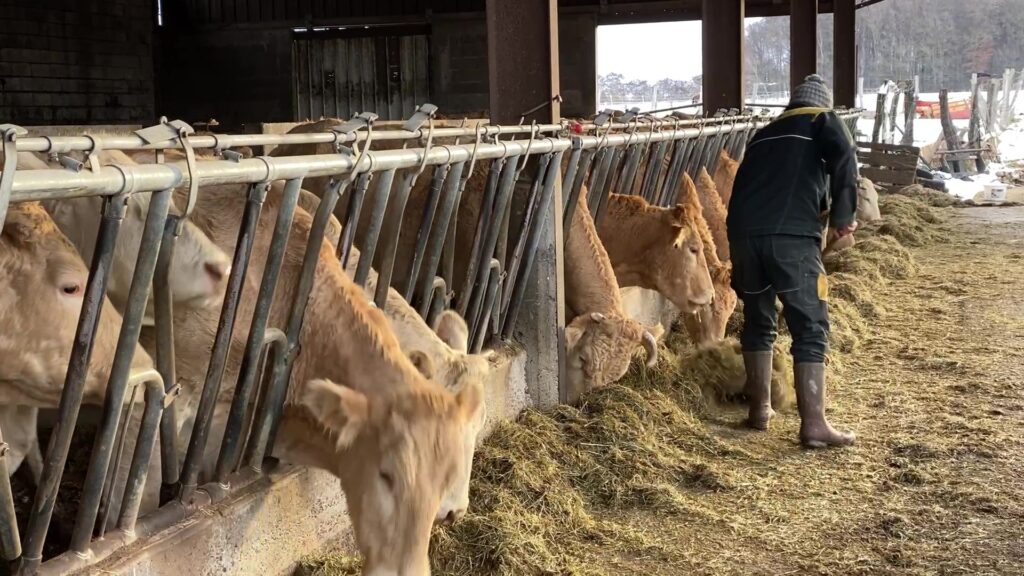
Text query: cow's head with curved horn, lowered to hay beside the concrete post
565 312 657 404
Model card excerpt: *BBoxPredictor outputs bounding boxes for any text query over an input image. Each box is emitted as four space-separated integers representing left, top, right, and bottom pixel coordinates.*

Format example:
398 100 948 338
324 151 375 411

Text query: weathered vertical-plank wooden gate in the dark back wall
292 31 430 122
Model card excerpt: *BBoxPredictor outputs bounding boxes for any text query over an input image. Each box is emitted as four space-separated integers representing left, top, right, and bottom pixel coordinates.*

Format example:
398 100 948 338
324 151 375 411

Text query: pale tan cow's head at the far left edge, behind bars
0 203 153 406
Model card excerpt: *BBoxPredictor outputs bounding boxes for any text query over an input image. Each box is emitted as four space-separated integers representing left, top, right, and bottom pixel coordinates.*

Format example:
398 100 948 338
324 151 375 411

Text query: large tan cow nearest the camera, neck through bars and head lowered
165 182 482 574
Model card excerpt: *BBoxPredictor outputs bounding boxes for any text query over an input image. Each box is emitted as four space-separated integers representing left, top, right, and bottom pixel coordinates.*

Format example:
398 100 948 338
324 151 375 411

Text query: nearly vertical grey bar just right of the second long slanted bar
153 214 181 485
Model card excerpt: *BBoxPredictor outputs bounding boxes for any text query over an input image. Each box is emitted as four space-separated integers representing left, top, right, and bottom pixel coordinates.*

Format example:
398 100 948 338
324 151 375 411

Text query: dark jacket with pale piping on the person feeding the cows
726 108 857 239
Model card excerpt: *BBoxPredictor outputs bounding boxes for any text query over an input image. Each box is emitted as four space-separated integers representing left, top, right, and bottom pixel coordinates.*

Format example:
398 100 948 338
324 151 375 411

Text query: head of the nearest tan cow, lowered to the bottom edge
300 380 481 576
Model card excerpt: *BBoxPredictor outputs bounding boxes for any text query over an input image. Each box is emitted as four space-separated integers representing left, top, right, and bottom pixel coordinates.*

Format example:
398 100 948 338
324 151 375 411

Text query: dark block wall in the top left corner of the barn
0 0 156 126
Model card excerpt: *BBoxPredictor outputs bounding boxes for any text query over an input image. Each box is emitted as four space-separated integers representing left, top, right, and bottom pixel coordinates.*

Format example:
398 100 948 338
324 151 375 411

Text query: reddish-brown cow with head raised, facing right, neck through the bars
597 194 714 315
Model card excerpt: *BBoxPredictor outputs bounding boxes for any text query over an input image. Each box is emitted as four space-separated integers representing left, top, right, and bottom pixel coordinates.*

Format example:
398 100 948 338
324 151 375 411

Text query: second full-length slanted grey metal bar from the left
71 189 173 552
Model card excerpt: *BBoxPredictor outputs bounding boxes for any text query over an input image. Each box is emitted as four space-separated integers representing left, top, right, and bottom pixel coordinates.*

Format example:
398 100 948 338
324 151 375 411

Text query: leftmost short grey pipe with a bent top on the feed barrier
118 370 166 533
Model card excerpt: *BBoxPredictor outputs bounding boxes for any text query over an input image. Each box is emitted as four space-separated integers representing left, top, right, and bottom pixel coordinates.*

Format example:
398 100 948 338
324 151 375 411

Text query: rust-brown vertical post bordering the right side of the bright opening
701 0 744 114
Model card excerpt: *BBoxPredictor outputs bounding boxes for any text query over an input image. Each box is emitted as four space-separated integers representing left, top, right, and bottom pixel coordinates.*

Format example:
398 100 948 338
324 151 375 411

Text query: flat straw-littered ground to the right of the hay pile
595 203 1024 575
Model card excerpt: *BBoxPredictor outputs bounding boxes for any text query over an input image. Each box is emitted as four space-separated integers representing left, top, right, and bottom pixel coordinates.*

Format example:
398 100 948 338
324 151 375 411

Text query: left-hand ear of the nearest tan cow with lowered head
300 380 370 448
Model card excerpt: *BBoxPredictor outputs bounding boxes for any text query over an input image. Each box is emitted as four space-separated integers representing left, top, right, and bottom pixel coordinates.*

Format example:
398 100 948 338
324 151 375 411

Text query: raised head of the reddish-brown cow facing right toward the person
648 204 715 314
